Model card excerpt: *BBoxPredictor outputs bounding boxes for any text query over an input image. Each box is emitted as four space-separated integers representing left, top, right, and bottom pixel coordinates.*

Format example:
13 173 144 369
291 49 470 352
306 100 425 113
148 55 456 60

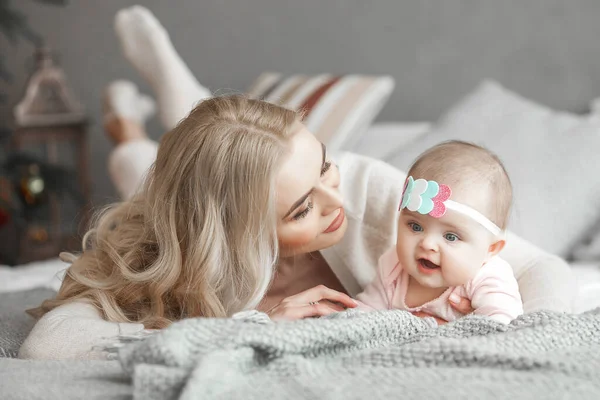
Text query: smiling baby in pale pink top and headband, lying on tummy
357 141 523 323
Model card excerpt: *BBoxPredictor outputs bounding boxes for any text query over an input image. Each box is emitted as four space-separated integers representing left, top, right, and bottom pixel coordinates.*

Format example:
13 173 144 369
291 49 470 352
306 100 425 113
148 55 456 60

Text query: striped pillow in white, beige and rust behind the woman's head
248 73 394 150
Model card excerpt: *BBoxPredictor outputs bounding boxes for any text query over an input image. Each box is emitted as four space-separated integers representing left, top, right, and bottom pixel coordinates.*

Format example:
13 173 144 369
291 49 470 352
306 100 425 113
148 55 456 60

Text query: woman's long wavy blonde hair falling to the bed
30 95 300 328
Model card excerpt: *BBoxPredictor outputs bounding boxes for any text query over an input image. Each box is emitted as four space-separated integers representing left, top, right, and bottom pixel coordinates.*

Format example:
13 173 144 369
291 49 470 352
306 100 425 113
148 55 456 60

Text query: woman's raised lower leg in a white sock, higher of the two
115 6 211 130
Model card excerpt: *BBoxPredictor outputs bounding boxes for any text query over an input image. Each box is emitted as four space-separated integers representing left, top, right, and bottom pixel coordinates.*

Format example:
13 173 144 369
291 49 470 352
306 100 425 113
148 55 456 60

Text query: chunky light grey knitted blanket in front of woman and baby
119 309 600 400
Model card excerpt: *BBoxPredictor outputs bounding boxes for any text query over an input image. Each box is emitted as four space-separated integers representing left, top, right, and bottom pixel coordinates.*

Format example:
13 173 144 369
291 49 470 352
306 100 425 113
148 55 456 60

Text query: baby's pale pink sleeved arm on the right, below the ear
467 257 523 324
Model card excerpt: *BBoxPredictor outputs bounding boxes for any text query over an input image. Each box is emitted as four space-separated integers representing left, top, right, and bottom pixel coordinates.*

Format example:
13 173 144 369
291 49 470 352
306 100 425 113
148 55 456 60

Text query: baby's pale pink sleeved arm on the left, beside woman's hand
356 247 398 311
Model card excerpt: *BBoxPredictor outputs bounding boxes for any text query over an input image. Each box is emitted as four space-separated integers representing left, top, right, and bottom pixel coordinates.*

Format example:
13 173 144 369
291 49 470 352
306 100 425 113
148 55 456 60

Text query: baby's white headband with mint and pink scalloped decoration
400 176 502 235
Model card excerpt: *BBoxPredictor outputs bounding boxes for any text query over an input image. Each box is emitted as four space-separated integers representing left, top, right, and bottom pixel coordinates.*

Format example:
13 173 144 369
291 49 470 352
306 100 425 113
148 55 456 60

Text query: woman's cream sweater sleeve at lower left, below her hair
19 302 144 360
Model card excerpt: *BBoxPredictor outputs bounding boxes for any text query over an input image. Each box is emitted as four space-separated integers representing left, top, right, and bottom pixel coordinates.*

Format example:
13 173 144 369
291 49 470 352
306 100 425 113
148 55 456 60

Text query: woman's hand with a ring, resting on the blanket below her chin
267 285 357 321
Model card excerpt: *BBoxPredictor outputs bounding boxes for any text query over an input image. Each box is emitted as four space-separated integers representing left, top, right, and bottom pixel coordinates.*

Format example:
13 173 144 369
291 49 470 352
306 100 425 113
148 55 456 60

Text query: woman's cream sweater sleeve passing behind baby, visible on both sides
321 153 577 313
